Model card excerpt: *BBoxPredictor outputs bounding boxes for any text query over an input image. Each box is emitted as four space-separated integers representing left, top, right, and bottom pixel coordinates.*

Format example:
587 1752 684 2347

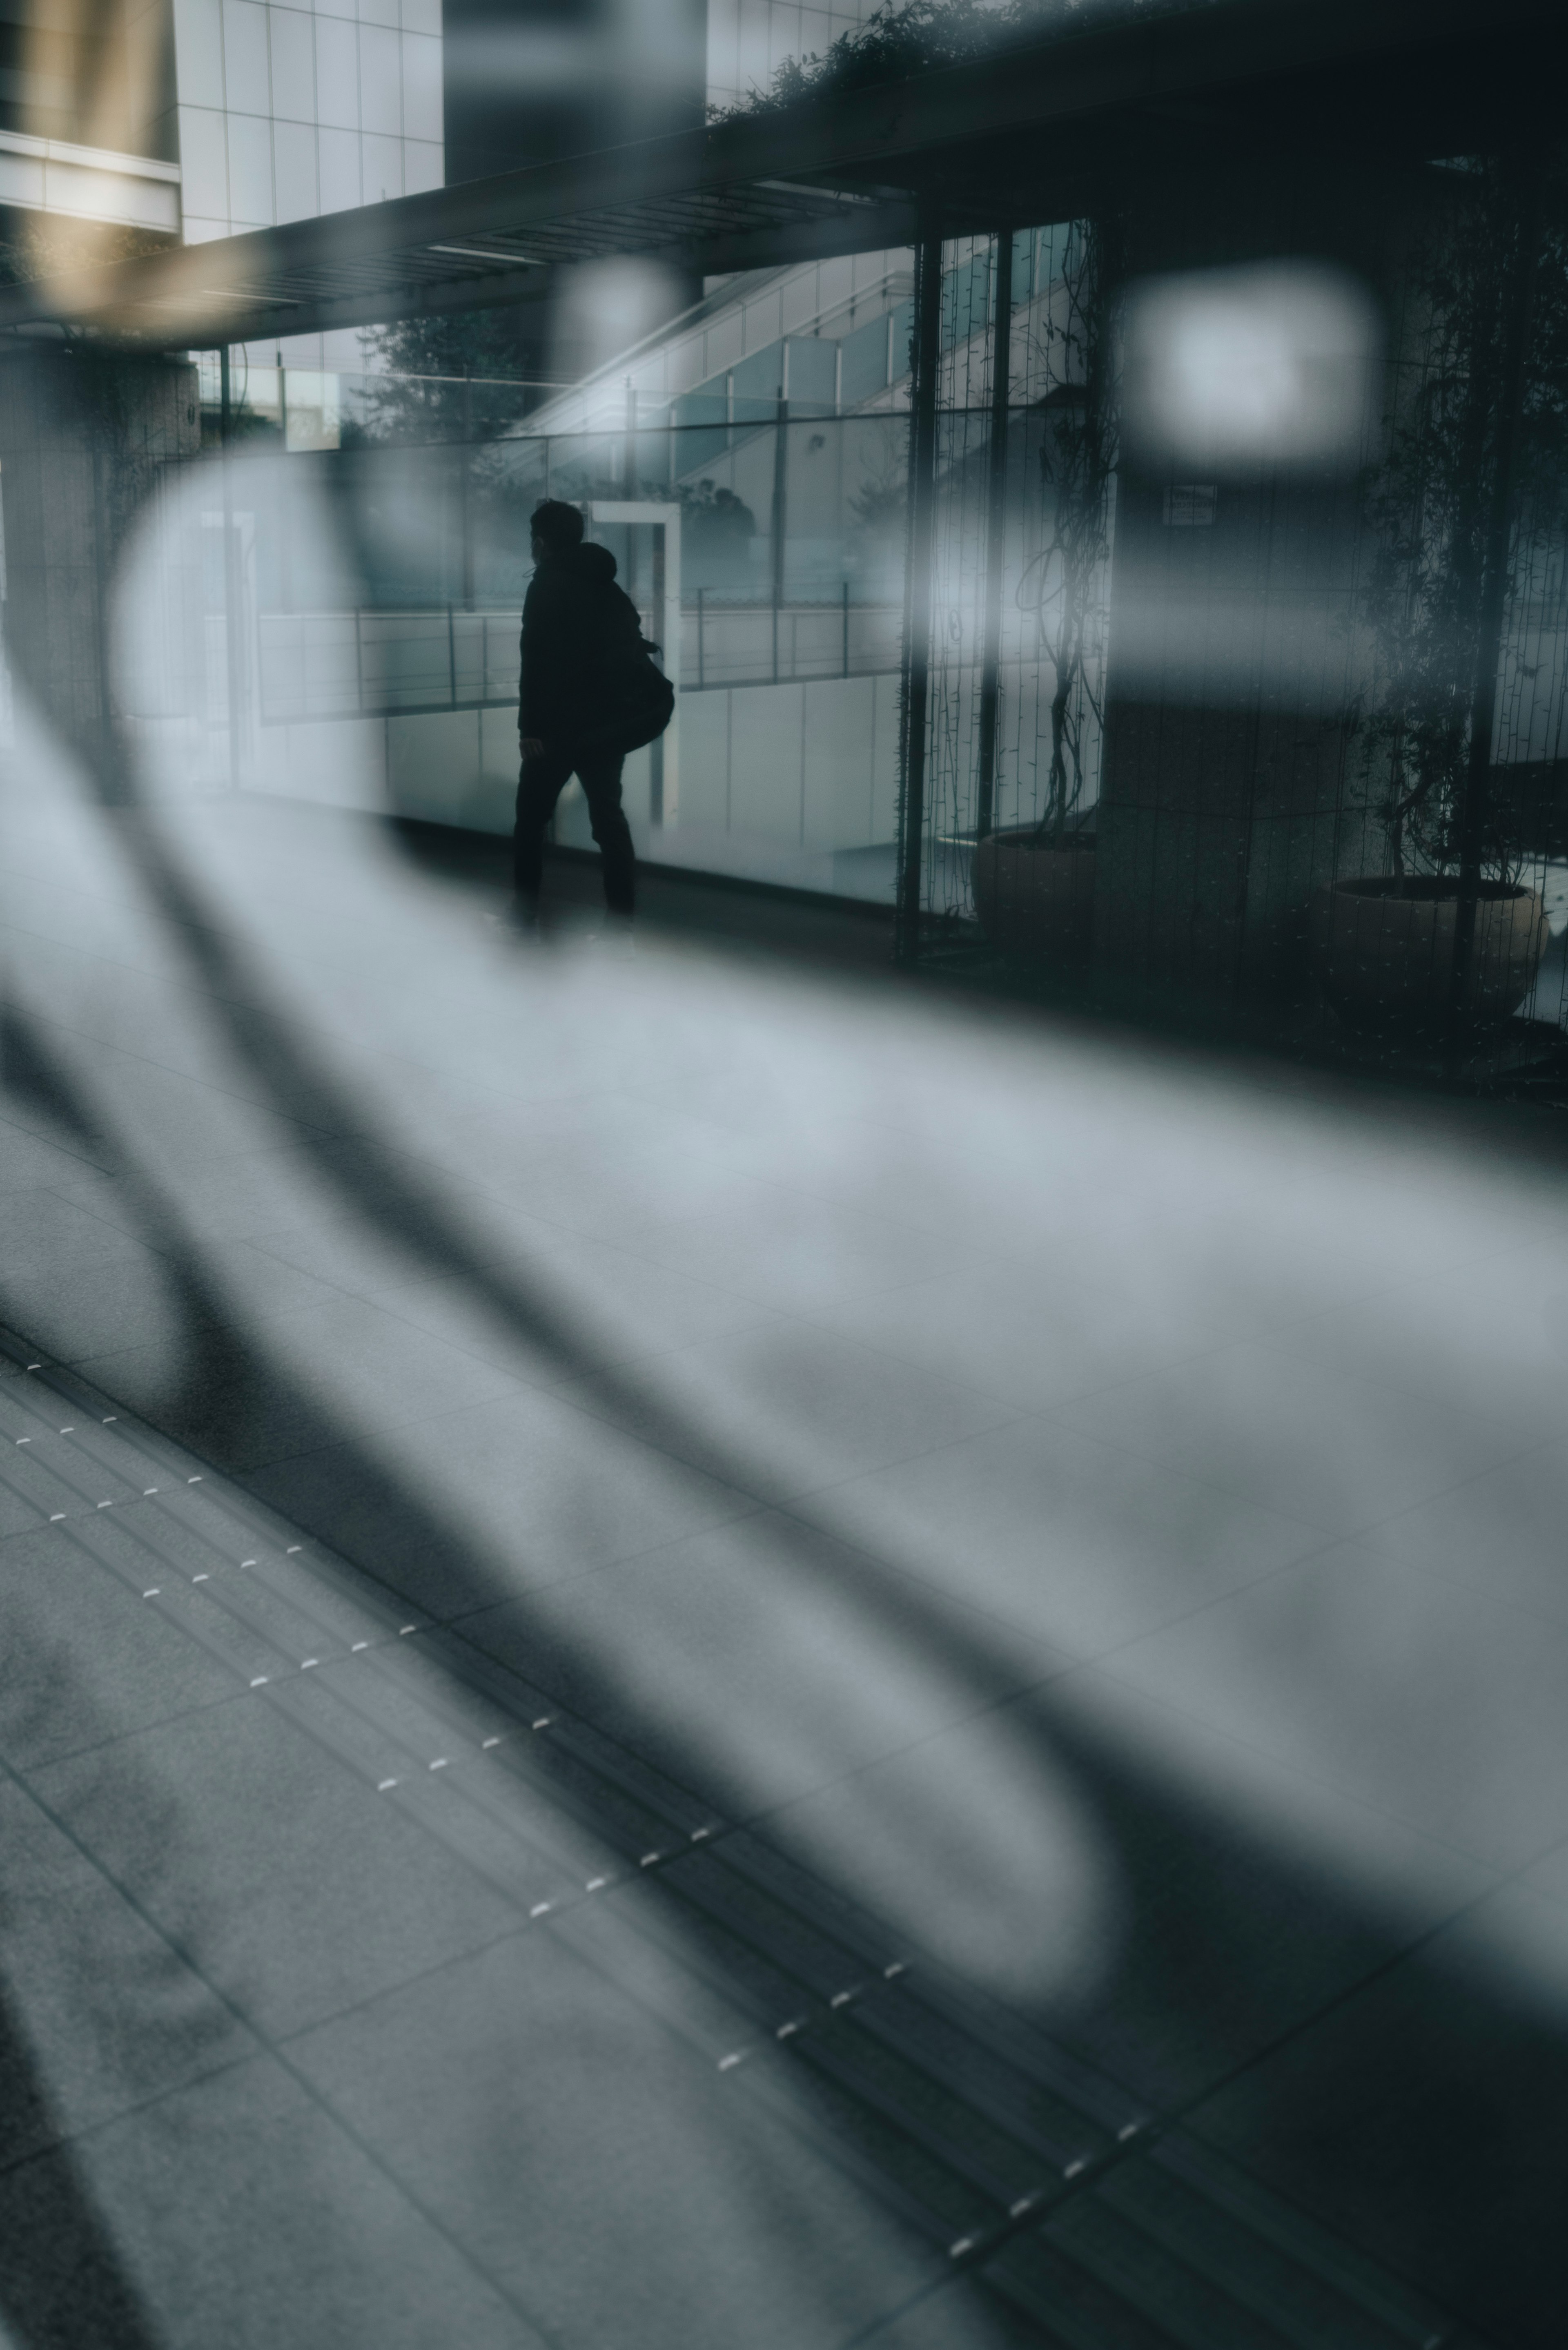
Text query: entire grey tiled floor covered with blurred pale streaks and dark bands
0 771 1568 2350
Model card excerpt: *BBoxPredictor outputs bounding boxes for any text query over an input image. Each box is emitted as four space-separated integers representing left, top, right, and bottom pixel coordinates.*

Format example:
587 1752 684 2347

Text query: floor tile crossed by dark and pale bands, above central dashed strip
461 1514 1065 1817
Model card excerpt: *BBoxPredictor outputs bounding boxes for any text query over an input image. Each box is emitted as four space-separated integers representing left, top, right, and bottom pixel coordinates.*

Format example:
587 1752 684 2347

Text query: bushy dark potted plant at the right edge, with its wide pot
1310 165 1568 1034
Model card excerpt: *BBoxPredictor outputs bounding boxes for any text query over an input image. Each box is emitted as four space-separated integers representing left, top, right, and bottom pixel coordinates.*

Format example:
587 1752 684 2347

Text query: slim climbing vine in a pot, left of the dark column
973 219 1119 968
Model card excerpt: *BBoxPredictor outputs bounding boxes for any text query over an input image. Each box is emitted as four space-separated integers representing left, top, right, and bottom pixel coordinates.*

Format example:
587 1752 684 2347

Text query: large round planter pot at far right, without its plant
1312 874 1547 1034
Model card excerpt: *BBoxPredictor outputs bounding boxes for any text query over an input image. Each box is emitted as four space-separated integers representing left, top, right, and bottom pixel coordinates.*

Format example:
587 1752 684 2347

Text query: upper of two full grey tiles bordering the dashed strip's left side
33 1692 515 2033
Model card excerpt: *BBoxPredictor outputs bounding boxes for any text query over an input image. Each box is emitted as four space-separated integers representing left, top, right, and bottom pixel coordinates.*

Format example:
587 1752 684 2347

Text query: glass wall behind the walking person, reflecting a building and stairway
236 230 1100 898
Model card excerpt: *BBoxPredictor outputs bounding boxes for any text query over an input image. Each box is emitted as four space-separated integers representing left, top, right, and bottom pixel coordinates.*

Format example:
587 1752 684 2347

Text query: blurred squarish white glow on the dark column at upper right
1126 261 1380 470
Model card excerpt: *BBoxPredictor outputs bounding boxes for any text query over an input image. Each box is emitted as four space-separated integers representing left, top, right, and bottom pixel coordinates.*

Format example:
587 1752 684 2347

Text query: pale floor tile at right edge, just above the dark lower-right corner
1105 1544 1568 1868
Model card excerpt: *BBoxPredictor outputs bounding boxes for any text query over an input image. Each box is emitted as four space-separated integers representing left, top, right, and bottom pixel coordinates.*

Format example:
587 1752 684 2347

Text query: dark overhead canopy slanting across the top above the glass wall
0 0 1568 350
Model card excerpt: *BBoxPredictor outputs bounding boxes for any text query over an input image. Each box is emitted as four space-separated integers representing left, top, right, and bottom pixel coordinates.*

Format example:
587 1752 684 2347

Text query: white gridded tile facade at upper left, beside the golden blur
174 0 444 242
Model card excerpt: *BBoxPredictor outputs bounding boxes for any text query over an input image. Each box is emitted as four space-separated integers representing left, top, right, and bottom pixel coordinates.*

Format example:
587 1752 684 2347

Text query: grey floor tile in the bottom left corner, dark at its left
0 2059 543 2350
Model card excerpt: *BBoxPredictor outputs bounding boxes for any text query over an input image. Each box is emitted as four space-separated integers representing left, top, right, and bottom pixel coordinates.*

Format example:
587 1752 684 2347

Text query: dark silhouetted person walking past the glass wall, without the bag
512 498 642 928
